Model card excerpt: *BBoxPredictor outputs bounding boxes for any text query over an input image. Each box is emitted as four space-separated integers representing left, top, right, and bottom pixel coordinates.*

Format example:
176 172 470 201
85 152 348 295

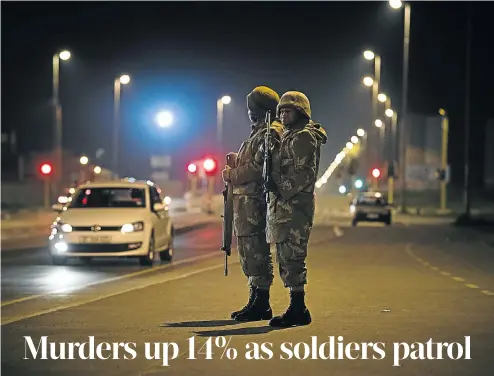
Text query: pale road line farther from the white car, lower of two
1 260 240 326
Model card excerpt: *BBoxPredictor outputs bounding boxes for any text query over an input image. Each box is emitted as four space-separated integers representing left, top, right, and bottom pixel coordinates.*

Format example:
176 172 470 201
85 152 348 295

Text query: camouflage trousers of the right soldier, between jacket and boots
276 239 308 288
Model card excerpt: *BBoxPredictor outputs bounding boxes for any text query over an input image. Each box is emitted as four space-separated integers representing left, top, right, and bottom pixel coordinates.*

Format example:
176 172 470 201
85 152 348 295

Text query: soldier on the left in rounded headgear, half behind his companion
222 86 283 321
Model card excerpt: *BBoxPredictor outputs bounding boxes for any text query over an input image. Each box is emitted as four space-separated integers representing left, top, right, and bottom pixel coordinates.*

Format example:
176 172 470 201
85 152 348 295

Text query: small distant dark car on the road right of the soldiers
350 192 392 226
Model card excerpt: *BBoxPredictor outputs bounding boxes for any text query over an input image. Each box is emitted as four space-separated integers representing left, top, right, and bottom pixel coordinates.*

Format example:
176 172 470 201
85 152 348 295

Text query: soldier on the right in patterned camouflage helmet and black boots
266 91 327 327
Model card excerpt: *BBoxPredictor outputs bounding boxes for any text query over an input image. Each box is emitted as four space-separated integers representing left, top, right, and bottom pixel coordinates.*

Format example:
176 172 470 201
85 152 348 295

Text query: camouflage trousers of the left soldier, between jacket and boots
237 233 273 289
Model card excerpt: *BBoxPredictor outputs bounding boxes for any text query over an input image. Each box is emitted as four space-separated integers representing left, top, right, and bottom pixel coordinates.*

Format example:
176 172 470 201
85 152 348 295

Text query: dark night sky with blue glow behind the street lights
2 2 494 184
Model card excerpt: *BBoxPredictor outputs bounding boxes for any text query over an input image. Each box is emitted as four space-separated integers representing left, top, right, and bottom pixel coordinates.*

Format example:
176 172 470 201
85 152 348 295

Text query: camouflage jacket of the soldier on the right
266 121 327 244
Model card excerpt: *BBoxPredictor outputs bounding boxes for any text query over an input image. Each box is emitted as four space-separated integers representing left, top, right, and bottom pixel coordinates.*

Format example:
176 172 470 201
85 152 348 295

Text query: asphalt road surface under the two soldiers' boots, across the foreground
2 223 494 376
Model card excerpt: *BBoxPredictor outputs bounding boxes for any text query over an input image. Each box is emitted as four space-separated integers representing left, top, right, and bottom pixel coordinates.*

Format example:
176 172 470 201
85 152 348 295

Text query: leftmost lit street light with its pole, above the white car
52 50 71 189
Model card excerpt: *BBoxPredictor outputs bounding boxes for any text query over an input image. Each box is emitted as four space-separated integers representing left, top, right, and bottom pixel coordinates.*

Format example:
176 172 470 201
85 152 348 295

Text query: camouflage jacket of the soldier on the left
230 120 283 236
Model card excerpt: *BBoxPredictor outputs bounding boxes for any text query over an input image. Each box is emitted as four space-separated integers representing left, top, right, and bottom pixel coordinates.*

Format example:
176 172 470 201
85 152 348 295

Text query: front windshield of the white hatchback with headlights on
69 188 146 209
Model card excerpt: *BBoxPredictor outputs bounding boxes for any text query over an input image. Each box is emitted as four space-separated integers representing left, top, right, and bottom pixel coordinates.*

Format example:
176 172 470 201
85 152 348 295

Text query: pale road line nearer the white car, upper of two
0 253 226 307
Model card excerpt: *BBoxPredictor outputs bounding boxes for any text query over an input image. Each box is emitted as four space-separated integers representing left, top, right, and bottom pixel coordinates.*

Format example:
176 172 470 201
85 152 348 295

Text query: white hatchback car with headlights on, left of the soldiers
49 180 174 266
